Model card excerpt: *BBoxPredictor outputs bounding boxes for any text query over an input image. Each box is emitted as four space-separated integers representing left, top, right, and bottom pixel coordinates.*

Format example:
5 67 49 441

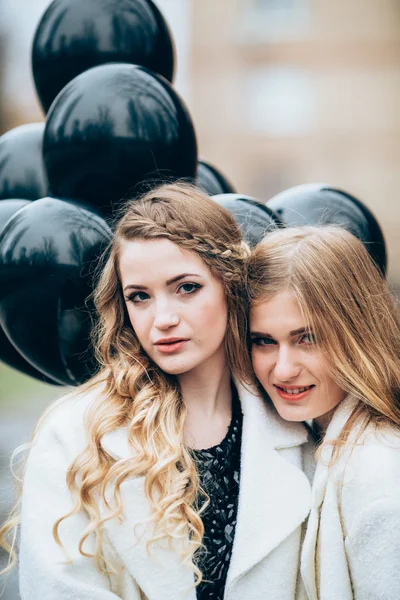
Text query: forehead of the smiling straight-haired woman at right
250 291 305 333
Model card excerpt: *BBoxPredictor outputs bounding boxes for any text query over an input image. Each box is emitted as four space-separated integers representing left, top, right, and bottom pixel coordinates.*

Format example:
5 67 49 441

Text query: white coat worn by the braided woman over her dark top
20 388 311 600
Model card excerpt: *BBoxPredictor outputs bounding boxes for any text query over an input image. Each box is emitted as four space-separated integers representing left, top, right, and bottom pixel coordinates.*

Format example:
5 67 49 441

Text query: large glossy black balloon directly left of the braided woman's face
0 198 111 385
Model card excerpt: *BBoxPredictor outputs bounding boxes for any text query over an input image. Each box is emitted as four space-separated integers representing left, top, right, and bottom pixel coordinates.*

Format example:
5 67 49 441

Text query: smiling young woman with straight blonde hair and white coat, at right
249 227 400 600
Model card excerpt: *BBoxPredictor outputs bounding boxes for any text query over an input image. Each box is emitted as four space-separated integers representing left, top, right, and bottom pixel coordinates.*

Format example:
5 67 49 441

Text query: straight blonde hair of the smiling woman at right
248 226 400 460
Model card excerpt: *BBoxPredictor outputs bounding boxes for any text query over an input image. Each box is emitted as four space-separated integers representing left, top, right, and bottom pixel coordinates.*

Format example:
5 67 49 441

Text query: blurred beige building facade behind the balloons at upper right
190 0 400 286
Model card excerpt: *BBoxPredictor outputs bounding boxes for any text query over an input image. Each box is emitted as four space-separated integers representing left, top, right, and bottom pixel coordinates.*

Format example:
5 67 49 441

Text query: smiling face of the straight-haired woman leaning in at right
250 291 345 426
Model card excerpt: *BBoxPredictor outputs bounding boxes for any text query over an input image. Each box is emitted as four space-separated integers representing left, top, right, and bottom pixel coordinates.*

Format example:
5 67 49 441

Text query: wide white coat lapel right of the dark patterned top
227 386 311 587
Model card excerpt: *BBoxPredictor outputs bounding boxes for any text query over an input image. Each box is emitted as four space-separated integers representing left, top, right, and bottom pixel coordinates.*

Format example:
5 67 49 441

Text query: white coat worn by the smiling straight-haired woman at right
301 397 400 600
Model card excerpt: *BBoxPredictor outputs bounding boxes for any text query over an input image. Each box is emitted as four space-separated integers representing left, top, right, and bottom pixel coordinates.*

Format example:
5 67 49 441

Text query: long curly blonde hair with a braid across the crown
0 183 250 584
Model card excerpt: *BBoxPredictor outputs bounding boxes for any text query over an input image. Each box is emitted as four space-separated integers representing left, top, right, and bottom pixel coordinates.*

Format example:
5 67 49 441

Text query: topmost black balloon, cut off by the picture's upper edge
32 0 174 113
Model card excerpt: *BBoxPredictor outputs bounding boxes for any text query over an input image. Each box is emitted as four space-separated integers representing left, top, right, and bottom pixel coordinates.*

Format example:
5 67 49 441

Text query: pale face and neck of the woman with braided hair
119 238 232 449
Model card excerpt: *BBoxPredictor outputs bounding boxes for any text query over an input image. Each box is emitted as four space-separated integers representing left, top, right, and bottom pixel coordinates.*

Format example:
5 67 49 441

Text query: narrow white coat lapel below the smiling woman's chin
301 396 357 600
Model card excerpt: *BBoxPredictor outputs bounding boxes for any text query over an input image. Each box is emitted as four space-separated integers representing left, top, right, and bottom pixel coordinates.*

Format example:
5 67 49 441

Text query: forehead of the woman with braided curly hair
119 238 209 283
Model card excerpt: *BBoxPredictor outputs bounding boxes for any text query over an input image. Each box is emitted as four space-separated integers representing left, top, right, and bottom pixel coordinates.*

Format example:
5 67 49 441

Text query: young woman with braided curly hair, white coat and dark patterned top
3 184 310 600
